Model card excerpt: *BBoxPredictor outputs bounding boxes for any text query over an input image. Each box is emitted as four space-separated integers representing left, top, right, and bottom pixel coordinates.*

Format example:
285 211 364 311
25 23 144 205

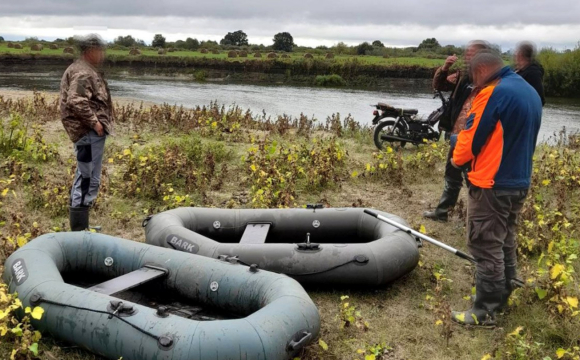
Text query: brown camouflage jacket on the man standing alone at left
60 60 115 142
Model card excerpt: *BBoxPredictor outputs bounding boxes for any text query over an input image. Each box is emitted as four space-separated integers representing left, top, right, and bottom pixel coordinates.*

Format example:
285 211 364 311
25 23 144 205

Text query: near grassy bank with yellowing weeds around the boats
0 94 580 360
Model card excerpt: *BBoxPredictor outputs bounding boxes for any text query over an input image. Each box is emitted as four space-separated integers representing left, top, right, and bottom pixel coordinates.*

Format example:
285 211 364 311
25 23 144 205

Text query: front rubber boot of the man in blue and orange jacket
451 279 506 327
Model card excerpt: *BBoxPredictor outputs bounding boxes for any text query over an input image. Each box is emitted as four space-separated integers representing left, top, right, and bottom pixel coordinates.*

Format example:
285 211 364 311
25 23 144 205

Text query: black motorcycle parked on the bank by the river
371 91 449 150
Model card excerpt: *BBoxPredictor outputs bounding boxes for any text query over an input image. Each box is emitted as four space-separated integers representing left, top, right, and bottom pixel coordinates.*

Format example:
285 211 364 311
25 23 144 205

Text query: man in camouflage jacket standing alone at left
60 35 114 231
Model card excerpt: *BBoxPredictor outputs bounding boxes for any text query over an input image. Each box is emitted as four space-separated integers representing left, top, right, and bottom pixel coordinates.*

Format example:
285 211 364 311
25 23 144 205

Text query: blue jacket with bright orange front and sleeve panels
453 67 542 190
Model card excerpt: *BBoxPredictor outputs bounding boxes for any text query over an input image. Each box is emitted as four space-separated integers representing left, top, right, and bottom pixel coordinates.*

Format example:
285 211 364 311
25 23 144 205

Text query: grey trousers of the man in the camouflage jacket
70 130 107 207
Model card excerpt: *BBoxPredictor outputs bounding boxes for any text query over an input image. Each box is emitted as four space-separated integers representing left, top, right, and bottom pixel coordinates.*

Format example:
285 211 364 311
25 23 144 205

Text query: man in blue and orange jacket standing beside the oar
451 50 542 326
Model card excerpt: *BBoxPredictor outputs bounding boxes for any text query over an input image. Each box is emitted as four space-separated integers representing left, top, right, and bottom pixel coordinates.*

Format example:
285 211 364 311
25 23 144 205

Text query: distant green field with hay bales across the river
0 43 444 67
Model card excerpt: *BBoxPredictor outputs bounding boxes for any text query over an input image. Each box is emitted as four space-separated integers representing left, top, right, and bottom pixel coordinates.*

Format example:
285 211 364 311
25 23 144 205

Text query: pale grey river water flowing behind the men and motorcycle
0 72 580 140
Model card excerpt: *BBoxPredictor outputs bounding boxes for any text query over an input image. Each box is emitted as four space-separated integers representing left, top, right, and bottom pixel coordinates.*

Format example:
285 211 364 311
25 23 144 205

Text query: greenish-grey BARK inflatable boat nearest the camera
3 232 320 360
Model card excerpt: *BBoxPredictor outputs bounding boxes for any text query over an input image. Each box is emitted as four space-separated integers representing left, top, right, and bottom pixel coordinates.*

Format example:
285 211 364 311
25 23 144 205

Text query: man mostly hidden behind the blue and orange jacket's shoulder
514 41 546 106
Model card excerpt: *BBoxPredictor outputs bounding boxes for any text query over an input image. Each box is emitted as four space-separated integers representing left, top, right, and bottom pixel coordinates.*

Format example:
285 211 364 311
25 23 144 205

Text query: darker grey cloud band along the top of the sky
0 0 580 27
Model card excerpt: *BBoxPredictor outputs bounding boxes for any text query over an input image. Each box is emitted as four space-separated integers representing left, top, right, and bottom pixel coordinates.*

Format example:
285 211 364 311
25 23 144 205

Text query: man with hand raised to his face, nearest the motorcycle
423 40 490 221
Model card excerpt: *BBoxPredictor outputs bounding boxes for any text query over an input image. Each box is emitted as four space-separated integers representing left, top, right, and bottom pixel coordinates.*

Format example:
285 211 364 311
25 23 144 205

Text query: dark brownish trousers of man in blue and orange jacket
467 186 528 292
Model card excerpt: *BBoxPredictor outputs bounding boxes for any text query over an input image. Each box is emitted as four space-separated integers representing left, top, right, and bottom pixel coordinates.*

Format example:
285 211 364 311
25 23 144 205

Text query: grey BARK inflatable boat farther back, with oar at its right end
143 206 419 286
